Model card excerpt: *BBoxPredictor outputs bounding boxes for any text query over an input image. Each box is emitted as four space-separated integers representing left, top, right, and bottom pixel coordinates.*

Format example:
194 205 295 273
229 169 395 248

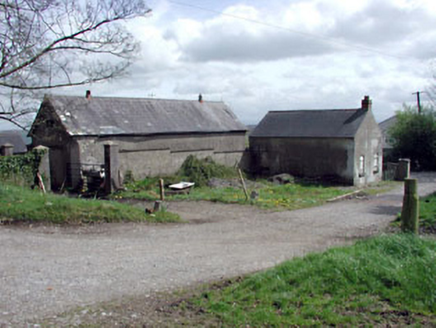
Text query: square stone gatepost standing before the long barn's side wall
104 142 121 194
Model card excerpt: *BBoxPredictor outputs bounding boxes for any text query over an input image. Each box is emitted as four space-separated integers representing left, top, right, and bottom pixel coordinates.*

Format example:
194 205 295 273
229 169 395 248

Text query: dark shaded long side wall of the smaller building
250 137 354 184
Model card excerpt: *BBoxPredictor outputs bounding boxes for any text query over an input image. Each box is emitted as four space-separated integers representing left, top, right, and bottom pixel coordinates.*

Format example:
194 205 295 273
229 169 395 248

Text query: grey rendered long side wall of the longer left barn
71 132 245 179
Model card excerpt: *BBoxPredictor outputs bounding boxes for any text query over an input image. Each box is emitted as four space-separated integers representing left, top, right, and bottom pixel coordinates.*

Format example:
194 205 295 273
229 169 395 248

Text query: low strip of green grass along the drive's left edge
0 184 180 224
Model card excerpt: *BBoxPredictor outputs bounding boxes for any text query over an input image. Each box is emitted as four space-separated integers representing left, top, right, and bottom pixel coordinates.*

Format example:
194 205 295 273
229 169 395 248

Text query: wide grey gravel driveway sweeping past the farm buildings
0 174 436 327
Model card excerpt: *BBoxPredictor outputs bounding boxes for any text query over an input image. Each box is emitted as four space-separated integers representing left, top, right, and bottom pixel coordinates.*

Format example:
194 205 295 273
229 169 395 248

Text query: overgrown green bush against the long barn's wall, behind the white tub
177 155 237 187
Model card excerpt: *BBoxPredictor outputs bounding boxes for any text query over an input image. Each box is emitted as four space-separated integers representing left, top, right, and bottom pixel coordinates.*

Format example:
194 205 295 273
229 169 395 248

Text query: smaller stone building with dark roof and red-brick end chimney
250 96 383 186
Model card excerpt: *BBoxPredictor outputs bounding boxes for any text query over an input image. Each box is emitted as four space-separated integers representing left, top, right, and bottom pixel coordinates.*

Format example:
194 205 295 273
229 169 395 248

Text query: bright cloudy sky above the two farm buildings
4 0 436 130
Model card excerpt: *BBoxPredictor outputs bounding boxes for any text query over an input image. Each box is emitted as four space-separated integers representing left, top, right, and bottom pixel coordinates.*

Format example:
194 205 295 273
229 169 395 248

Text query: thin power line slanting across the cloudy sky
167 0 412 59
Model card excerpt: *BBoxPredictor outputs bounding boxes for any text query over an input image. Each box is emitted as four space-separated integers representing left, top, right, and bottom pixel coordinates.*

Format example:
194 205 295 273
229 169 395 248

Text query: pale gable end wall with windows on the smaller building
354 112 383 186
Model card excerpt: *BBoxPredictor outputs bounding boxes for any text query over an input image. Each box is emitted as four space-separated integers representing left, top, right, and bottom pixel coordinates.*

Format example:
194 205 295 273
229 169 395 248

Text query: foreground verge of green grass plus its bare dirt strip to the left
36 234 436 327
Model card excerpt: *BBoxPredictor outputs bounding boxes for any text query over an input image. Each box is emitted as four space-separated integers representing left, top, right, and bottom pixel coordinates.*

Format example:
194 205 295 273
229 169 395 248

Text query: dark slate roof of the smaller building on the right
251 108 367 138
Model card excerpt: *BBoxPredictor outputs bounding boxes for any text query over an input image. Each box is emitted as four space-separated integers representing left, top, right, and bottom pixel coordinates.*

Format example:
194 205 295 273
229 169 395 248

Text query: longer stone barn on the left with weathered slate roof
29 92 246 190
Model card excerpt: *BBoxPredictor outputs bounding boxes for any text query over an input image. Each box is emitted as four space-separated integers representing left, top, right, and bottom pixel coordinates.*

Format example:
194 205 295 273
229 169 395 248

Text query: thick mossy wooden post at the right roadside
401 179 419 234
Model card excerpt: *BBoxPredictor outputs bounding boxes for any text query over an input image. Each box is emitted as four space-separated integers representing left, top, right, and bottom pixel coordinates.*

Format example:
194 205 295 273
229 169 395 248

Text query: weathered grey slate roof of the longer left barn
43 96 247 135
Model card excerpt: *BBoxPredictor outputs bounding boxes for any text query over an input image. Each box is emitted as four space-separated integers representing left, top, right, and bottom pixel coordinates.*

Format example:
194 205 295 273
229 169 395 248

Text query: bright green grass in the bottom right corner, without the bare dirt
190 235 436 327
